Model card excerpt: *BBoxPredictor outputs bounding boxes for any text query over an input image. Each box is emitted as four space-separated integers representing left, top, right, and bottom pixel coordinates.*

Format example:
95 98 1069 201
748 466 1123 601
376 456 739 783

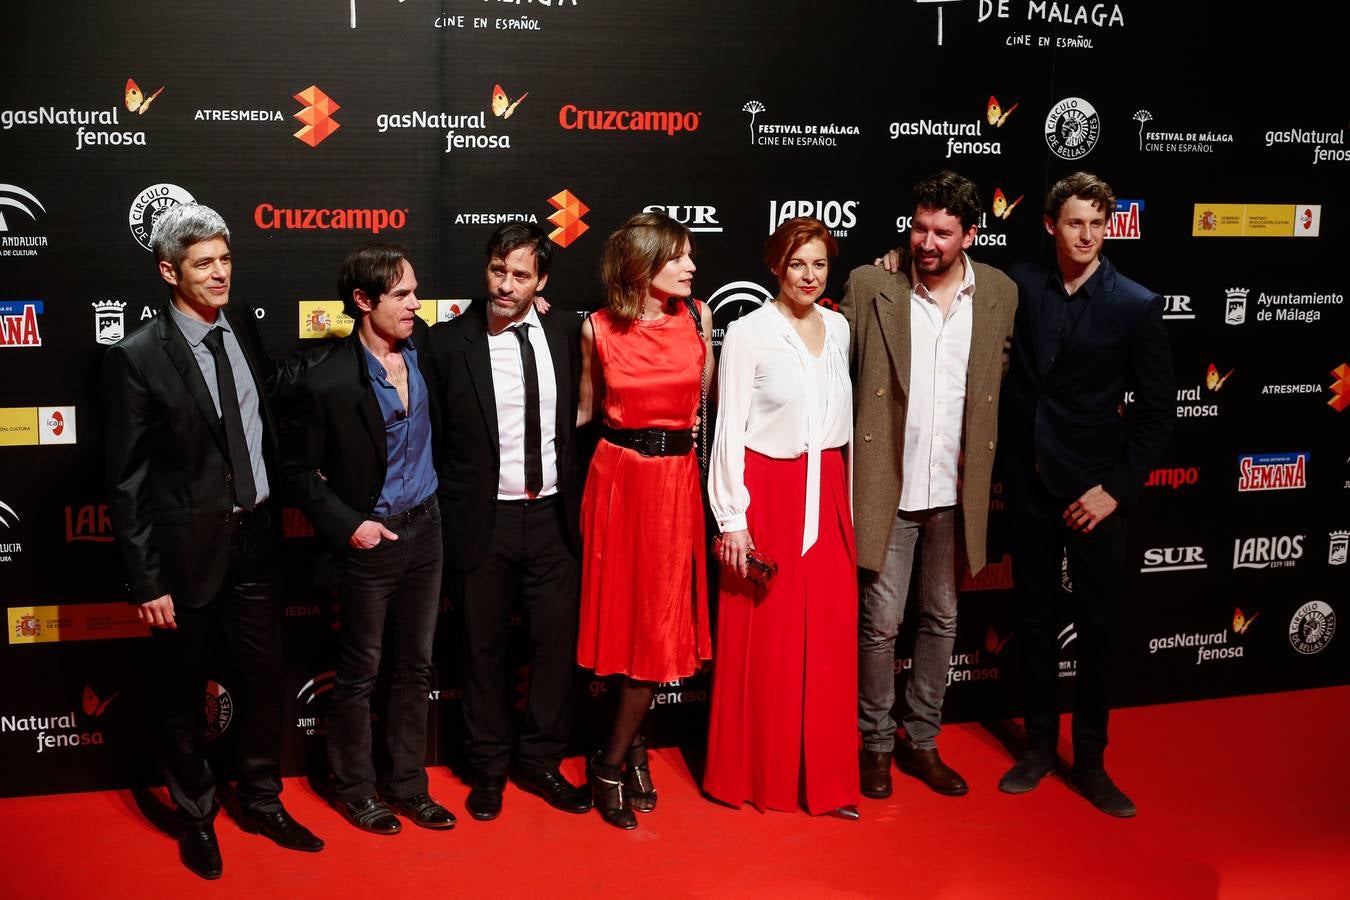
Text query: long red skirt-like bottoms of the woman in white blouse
703 449 859 815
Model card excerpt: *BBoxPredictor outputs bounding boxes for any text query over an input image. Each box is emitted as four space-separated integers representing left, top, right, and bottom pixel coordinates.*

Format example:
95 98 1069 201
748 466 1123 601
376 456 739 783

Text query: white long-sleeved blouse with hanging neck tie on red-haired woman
707 304 853 555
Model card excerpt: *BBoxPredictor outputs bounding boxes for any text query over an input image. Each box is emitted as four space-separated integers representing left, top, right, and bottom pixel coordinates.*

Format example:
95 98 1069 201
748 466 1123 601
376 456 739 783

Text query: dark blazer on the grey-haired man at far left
103 304 281 609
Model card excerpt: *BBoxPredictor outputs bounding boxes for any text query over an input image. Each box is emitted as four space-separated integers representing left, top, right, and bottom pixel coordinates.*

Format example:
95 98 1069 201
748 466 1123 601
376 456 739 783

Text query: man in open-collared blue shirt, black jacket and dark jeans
282 243 455 834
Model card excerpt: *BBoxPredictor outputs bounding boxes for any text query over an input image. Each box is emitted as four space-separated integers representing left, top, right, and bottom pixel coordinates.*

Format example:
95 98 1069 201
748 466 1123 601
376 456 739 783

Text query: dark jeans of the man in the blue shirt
327 497 441 801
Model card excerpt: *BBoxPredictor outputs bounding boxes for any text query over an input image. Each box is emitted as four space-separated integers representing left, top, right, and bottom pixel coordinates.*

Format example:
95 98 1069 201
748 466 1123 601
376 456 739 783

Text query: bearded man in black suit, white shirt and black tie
431 223 590 820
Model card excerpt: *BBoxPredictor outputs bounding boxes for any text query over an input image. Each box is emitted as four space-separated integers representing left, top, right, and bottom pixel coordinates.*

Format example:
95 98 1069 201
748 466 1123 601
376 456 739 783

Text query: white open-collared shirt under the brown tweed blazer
900 254 975 511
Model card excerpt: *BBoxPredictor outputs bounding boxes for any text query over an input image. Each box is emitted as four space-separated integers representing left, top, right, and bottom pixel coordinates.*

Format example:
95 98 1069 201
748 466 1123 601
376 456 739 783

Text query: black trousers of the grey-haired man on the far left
151 505 282 822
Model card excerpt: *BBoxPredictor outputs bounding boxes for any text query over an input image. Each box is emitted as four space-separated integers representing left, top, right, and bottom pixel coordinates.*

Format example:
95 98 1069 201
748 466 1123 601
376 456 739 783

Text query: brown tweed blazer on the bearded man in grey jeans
840 255 1017 573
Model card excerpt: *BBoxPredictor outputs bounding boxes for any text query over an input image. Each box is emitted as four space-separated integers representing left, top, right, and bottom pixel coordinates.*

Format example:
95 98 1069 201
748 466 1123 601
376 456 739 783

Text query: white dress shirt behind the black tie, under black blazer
487 306 558 501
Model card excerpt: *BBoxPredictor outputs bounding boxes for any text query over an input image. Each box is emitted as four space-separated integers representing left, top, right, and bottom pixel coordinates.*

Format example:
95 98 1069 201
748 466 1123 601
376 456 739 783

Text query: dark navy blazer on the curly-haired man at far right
999 256 1176 509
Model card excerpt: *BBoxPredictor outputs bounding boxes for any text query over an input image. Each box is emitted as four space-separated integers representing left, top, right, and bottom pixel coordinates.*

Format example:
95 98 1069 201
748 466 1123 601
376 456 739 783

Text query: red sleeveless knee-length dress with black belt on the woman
576 309 713 681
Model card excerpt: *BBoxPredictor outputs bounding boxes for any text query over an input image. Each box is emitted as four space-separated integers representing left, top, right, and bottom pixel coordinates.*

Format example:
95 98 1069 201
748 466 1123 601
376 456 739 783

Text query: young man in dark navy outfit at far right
999 173 1176 816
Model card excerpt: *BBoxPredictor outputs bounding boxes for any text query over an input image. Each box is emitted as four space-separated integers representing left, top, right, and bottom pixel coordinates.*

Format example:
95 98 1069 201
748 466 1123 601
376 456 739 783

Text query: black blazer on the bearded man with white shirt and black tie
431 300 582 572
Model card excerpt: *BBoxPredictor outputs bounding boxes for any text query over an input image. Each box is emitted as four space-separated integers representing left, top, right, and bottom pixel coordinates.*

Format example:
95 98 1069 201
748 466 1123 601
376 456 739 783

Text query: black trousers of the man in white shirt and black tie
462 497 581 777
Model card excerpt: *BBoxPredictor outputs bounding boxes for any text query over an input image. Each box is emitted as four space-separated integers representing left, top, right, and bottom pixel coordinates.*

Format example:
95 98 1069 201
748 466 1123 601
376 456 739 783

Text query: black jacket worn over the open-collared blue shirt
281 318 436 549
